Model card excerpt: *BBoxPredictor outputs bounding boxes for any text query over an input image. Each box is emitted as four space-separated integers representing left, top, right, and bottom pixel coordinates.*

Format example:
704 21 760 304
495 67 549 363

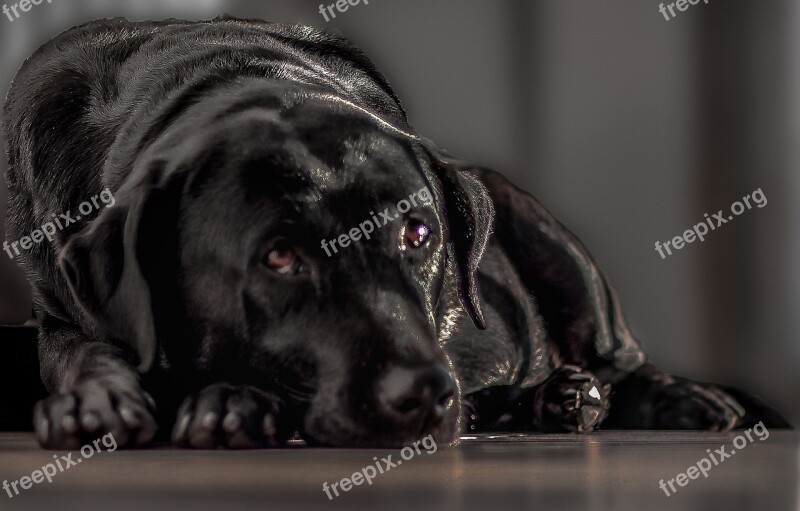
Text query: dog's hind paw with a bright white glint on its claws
534 365 611 433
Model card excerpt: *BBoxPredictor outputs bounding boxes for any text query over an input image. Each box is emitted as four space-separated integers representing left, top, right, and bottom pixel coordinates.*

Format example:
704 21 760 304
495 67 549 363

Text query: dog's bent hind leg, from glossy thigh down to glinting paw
454 169 645 432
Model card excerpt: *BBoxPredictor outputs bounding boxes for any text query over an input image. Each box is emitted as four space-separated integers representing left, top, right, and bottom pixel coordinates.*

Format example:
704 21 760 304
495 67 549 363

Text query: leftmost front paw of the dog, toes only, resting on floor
33 379 158 450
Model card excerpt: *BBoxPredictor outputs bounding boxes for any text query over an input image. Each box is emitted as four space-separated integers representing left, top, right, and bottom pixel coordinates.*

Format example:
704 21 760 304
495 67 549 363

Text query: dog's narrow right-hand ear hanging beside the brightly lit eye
426 148 494 330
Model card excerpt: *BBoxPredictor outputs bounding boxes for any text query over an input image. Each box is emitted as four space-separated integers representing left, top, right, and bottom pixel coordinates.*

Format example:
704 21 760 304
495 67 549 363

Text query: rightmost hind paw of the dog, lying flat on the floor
648 381 745 431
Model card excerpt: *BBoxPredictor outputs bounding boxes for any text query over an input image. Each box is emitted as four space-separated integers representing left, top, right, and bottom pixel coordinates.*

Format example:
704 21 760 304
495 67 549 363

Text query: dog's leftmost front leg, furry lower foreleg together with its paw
34 316 157 449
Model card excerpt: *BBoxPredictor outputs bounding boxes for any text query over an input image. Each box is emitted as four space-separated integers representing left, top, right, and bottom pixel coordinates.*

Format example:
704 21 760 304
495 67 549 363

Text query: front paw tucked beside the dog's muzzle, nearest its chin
172 383 294 449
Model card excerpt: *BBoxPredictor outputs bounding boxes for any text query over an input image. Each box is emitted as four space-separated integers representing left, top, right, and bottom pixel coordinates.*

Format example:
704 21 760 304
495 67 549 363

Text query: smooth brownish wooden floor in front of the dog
0 431 800 511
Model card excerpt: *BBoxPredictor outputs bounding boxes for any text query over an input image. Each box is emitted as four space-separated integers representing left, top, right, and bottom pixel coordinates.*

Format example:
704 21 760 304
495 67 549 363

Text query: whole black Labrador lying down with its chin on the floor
5 18 786 448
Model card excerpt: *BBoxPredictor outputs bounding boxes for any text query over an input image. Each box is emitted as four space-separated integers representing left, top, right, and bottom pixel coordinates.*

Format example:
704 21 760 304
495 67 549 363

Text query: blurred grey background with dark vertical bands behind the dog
0 0 800 425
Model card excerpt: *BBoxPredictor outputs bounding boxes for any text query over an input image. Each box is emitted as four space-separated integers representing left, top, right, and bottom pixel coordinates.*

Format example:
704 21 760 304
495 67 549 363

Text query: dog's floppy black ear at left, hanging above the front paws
60 166 179 373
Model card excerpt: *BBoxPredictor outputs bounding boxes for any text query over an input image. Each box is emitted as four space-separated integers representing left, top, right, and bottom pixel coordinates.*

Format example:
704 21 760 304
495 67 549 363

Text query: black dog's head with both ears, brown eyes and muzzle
62 82 493 446
